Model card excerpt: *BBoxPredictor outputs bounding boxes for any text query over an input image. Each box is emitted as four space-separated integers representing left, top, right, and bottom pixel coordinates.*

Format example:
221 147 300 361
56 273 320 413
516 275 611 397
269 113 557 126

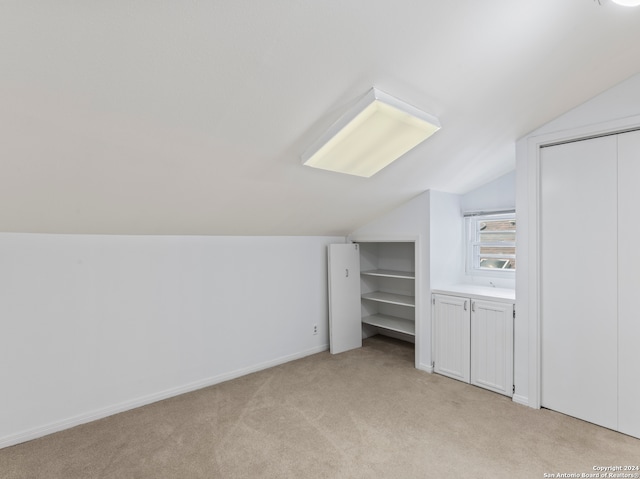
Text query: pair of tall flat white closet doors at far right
540 127 640 437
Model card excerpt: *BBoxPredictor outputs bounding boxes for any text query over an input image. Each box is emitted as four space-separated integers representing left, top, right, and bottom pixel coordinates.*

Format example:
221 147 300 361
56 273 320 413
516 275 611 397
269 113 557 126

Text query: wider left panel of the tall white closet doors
540 136 618 429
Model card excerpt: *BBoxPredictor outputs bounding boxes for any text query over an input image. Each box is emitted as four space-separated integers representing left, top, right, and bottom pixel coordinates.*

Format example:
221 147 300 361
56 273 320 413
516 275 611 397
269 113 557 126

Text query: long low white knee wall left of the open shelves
0 234 345 447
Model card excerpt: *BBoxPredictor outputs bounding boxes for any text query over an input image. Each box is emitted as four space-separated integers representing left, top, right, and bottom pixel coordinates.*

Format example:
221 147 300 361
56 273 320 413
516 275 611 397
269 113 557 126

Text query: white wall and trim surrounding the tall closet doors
514 70 640 407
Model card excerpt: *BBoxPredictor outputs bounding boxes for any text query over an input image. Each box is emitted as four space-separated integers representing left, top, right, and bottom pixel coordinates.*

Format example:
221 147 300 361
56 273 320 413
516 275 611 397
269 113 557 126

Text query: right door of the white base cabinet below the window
471 301 513 396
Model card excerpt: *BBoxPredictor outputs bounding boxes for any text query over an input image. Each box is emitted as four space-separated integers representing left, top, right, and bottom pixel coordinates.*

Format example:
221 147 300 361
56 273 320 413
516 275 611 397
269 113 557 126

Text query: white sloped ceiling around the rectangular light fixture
0 0 640 235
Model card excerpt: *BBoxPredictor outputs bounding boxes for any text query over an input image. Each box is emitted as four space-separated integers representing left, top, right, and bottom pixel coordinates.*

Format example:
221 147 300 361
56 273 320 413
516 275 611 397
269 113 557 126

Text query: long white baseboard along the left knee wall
0 344 329 449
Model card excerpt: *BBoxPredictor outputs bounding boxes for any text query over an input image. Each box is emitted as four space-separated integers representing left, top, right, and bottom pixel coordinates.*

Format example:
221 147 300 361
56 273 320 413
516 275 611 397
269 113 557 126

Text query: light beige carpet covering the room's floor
0 336 640 479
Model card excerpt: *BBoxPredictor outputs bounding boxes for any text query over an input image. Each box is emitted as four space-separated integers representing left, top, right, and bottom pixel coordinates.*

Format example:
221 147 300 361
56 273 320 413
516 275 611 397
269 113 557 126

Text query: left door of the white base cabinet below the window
433 295 470 382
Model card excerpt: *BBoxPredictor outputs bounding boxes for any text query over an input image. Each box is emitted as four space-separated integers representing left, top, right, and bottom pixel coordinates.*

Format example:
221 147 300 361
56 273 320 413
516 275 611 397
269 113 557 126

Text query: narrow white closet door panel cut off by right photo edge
618 131 640 437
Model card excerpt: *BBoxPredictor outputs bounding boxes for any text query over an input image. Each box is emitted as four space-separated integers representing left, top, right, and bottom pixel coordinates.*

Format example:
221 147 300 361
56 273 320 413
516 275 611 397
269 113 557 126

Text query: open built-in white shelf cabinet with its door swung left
329 241 418 366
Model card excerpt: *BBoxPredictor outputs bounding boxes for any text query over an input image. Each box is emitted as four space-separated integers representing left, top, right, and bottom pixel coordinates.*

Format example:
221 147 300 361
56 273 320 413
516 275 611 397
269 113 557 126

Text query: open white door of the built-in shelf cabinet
329 244 362 354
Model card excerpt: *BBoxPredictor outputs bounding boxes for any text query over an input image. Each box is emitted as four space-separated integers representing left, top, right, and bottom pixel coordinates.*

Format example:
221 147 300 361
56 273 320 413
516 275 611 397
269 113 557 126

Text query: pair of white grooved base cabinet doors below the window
432 294 514 396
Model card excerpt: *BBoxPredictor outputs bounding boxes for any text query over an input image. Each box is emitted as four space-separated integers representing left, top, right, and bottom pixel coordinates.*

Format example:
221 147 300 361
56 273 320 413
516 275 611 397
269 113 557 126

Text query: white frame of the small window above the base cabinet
465 210 517 278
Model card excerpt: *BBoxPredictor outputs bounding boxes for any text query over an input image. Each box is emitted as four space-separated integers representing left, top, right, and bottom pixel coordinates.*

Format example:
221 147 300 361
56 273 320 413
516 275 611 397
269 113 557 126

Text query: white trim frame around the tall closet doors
514 115 640 409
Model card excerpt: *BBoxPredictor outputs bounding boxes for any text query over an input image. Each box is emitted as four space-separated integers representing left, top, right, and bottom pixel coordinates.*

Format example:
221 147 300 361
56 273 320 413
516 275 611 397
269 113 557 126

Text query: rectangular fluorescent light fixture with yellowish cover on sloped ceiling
302 88 440 178
